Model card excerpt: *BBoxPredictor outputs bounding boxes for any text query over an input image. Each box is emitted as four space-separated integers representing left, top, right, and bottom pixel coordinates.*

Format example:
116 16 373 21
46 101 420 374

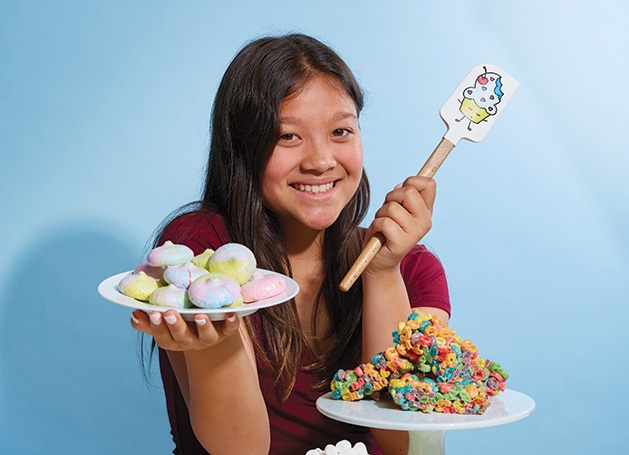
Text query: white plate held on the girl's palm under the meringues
98 269 299 321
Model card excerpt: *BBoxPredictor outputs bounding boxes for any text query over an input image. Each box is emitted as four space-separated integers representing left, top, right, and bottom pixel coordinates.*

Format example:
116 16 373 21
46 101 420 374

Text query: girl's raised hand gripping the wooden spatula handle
365 176 437 273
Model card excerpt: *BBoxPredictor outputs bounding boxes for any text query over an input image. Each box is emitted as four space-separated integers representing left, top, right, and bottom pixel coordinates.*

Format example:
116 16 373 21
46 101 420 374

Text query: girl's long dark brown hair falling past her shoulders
162 34 369 400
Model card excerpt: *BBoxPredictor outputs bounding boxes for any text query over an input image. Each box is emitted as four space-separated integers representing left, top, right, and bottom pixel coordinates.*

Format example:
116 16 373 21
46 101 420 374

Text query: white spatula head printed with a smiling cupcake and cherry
439 64 520 145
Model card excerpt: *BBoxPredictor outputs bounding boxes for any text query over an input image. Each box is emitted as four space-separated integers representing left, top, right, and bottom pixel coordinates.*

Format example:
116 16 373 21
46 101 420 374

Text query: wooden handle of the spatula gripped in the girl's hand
339 137 454 292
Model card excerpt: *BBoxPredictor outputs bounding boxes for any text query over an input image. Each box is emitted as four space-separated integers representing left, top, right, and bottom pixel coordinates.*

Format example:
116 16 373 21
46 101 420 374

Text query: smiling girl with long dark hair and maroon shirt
132 34 450 455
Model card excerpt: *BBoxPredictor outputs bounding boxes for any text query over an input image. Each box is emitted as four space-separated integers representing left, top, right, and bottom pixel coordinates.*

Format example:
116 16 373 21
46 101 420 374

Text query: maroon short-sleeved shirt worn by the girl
159 212 450 455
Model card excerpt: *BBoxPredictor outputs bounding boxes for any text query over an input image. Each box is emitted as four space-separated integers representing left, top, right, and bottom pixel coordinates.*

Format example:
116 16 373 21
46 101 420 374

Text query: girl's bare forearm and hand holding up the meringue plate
132 310 270 455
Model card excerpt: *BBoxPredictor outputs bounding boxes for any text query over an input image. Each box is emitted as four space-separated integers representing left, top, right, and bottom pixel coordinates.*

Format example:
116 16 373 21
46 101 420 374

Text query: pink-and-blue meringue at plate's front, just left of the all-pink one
188 273 242 309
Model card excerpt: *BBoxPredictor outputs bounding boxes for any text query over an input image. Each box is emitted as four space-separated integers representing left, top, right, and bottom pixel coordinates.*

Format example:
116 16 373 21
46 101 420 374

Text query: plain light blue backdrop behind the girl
0 0 629 455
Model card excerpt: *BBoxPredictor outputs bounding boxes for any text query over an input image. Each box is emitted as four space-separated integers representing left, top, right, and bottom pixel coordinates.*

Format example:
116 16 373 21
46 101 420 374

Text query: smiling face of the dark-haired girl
262 76 363 233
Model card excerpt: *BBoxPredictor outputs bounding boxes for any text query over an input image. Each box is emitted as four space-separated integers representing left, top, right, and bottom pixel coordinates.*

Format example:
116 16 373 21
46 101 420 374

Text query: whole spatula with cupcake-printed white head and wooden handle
339 65 519 292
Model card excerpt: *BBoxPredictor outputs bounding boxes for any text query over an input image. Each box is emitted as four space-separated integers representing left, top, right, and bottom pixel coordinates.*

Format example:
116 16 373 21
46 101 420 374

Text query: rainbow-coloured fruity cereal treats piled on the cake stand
331 310 509 414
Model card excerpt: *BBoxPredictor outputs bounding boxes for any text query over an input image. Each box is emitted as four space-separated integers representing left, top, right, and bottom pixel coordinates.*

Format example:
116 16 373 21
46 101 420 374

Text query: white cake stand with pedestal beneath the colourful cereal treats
317 389 535 455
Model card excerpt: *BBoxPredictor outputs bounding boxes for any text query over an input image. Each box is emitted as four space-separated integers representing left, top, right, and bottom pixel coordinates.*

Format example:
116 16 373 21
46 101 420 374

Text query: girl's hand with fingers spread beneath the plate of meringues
131 310 240 351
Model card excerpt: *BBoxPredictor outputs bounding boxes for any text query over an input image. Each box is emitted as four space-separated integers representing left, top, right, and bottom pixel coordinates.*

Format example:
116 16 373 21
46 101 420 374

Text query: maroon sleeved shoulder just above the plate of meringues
158 208 230 254
